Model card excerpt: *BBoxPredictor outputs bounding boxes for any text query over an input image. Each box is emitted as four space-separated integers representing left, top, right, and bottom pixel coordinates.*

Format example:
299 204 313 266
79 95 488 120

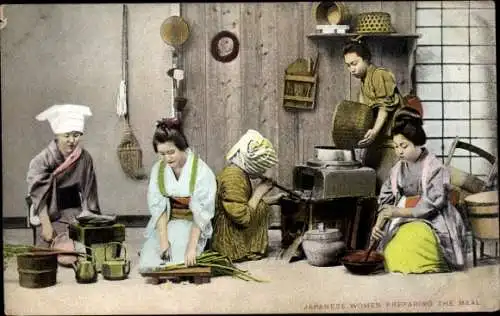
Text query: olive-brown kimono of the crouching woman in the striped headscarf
212 165 269 261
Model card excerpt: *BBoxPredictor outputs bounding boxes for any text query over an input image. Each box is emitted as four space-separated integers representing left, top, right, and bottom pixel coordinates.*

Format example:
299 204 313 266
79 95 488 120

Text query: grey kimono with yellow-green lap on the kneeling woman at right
378 149 465 273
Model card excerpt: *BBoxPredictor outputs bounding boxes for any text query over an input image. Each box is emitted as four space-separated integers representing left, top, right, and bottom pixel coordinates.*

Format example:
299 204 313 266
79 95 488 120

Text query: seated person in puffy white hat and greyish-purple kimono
27 104 101 252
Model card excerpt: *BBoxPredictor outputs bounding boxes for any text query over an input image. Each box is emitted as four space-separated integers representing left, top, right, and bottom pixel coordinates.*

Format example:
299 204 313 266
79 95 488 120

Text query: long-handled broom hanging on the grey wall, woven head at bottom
116 4 146 180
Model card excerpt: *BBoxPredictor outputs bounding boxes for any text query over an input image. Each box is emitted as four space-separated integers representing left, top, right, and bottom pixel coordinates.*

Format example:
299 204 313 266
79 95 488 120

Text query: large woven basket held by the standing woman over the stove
332 100 375 149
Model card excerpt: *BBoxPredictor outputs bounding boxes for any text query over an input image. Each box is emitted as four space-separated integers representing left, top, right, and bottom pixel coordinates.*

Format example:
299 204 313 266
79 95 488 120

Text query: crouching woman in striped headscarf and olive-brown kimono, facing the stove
212 130 281 261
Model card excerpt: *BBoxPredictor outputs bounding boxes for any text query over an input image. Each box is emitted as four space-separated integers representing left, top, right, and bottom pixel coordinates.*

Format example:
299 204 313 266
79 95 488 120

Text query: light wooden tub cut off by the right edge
465 191 500 239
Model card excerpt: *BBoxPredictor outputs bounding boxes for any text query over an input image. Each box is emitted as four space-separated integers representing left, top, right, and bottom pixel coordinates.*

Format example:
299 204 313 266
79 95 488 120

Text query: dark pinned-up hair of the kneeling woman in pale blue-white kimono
153 117 189 152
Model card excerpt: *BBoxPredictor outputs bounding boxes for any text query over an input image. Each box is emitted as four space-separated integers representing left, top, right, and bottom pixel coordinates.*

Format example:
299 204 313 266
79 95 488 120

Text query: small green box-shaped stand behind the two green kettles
68 223 125 272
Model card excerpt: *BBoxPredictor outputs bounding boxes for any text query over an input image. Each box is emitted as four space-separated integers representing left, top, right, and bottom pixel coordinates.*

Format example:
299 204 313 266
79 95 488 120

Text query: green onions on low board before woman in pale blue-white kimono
154 251 266 282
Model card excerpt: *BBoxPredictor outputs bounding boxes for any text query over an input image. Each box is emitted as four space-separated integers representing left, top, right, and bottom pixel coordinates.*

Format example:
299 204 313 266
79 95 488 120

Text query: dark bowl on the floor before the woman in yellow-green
340 250 384 275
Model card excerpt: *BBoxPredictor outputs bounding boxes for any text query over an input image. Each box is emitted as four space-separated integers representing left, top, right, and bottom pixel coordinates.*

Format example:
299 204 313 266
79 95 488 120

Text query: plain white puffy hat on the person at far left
36 104 92 134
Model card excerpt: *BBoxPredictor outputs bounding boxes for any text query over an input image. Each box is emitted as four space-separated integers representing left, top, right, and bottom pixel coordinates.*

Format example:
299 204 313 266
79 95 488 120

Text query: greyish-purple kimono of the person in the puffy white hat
27 140 101 247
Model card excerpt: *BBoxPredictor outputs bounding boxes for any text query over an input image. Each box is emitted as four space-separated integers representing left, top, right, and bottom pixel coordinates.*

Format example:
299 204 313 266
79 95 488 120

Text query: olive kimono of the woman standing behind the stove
359 64 403 192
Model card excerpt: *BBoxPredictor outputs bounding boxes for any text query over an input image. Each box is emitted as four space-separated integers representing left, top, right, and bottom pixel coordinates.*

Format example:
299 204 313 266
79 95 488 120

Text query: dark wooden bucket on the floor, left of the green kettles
17 252 57 288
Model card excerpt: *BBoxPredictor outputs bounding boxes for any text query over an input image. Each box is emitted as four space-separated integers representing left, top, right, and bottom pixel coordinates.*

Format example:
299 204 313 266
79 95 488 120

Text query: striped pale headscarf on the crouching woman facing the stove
226 129 278 174
